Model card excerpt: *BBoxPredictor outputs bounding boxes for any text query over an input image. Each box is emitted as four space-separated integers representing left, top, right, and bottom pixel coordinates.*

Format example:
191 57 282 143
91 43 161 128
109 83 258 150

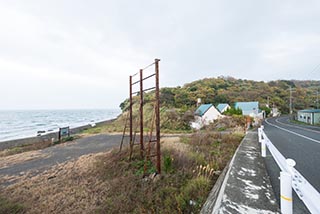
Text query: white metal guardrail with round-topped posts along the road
258 126 320 214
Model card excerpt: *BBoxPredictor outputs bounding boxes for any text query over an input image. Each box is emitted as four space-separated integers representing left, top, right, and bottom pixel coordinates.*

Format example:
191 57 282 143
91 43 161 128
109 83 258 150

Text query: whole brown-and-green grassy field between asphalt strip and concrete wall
1 133 241 213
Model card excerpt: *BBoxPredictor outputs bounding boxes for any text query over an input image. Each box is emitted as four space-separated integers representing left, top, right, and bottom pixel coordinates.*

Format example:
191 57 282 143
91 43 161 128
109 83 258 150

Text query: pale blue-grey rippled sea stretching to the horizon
0 109 121 142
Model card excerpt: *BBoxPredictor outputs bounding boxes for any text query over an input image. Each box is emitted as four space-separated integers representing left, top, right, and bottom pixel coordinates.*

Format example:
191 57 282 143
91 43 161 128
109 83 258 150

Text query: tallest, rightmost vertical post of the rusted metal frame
155 59 161 174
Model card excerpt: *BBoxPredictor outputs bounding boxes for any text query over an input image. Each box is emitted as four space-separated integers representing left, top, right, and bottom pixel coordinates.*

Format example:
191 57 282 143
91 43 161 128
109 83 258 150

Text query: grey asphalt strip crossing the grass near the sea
0 134 128 185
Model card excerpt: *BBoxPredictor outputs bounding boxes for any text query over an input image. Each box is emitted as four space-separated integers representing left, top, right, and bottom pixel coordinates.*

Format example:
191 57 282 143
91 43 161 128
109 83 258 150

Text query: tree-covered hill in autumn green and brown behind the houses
120 76 320 113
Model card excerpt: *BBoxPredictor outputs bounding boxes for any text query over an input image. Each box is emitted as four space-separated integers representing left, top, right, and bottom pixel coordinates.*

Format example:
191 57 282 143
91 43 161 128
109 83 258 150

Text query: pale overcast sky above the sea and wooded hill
0 0 320 109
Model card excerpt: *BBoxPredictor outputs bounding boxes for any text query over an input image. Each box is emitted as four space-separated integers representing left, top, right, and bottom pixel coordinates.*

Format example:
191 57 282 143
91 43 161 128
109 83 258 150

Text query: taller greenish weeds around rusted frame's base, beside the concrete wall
96 133 243 213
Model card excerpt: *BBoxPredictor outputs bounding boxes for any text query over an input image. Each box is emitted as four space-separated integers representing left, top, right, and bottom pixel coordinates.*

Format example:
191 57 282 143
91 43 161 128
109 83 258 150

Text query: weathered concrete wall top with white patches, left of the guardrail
201 131 279 213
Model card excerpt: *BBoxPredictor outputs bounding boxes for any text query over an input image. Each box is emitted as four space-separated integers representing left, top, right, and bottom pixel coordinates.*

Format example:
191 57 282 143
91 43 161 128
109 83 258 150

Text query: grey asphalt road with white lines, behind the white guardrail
264 117 320 213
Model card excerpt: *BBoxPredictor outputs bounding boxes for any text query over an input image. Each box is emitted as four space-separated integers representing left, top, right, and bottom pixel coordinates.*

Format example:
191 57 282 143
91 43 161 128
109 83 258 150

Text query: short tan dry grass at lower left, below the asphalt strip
2 154 109 213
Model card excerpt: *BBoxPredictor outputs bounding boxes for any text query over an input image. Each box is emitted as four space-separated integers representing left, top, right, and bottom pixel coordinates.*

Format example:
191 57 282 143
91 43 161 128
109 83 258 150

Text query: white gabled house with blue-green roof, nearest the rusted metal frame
191 104 222 129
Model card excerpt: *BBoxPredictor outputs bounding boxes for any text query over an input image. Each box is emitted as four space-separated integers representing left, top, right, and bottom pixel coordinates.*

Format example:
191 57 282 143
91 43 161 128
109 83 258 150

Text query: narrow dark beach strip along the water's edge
0 118 116 151
